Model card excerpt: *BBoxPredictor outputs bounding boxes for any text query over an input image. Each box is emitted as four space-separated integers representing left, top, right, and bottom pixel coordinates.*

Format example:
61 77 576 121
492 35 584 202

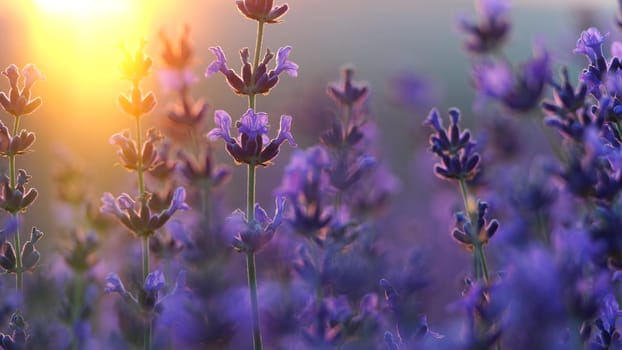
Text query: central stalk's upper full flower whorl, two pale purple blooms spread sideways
205 46 298 95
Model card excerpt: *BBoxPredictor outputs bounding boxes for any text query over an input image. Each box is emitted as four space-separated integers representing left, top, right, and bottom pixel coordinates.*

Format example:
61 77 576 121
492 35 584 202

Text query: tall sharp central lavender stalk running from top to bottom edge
205 0 298 350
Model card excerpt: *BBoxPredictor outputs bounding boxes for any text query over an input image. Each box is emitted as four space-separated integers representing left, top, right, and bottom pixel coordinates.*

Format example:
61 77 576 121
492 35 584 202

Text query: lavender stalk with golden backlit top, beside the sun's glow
101 41 189 350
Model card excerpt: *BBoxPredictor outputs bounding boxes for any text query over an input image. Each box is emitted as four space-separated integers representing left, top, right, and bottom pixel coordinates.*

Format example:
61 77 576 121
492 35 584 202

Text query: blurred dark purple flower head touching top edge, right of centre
459 0 510 54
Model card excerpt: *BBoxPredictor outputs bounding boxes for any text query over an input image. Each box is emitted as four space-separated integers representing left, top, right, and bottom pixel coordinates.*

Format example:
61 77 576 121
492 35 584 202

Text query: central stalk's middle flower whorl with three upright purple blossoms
207 109 297 166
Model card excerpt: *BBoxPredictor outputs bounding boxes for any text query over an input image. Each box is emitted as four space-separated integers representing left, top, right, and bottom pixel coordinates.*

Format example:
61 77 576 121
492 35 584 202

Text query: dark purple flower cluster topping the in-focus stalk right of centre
424 108 480 180
